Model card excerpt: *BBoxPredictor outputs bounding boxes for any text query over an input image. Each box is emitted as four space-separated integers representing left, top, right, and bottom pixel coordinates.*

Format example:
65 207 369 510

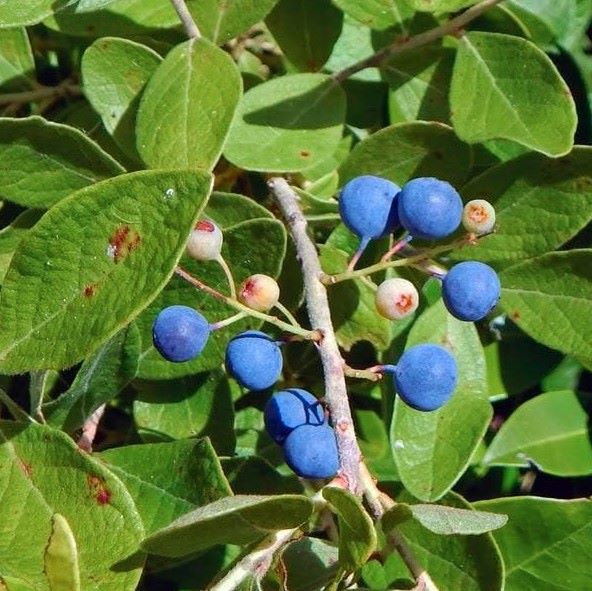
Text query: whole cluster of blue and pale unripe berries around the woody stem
153 175 500 478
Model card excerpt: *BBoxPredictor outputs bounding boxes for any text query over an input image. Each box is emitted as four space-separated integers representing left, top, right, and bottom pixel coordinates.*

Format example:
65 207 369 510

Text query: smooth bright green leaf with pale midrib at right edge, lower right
483 392 592 476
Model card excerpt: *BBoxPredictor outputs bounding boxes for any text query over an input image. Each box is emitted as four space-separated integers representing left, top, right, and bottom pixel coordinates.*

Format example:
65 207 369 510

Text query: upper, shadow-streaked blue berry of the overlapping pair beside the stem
263 388 325 443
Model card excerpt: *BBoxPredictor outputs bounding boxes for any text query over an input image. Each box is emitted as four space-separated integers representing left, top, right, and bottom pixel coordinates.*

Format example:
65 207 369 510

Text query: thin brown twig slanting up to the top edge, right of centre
333 0 503 82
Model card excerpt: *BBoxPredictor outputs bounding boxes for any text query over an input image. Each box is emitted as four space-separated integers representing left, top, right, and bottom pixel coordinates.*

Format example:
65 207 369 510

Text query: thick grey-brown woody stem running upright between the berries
268 177 362 494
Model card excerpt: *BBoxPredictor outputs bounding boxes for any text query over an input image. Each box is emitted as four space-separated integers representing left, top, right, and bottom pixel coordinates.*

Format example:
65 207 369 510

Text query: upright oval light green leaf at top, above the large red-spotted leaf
136 38 242 170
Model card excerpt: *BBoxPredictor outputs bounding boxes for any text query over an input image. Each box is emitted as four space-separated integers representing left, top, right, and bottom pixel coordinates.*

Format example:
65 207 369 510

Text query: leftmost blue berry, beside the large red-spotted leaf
152 306 210 363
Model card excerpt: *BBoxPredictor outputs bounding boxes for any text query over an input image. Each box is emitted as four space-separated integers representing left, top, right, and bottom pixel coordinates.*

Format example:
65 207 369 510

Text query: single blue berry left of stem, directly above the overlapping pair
226 330 283 390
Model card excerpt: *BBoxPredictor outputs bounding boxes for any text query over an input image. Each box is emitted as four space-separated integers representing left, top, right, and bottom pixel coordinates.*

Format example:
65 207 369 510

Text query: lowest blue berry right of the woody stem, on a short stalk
393 344 458 411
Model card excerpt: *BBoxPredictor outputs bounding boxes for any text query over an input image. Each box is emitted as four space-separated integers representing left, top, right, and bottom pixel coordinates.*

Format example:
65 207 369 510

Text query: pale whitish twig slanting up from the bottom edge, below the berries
210 529 298 591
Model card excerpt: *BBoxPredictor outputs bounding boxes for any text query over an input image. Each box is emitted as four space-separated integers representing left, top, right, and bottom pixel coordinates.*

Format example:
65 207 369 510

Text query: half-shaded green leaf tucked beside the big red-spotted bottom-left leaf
98 439 232 534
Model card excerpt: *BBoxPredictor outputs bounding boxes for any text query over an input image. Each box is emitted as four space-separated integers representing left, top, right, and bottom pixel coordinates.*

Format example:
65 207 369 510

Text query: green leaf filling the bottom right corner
475 497 592 591
